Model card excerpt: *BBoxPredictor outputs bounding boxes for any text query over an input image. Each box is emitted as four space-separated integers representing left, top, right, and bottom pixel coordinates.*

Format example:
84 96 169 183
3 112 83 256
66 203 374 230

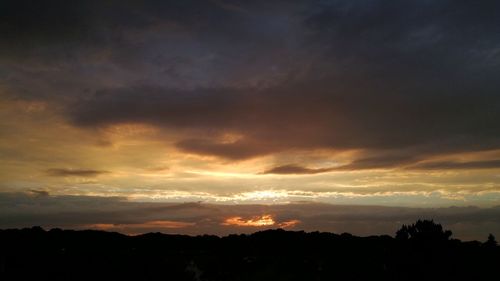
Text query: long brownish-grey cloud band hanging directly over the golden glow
68 81 500 163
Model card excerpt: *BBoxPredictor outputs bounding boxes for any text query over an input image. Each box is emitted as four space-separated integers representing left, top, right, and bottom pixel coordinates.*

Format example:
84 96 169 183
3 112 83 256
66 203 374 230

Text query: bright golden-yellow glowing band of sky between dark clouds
0 92 500 208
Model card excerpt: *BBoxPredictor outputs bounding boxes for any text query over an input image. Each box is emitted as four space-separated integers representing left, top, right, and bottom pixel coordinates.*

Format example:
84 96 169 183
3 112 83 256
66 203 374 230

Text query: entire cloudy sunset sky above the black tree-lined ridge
0 0 500 239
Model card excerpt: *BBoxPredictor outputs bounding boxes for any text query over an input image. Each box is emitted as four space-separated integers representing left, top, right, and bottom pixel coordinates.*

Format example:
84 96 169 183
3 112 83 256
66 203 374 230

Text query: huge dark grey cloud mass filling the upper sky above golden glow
0 0 500 164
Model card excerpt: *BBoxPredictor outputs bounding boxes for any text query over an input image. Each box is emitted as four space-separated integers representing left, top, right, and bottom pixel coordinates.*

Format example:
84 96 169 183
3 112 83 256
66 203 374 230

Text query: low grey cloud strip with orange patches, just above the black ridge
0 193 500 240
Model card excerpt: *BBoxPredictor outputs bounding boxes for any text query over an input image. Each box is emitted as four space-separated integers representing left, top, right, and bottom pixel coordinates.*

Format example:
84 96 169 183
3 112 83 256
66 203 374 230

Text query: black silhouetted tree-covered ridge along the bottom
0 221 500 281
